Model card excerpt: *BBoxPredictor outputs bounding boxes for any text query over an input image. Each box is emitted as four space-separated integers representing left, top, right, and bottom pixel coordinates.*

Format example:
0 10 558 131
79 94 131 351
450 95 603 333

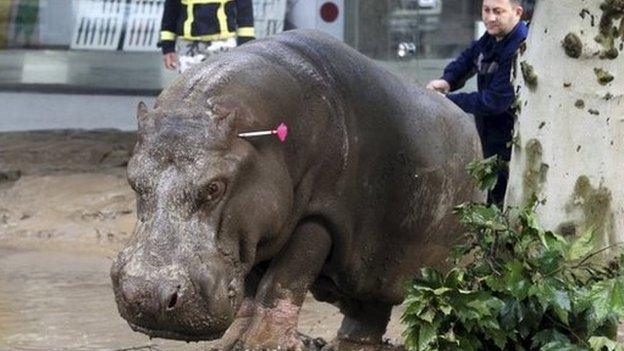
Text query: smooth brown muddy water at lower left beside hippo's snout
0 248 202 351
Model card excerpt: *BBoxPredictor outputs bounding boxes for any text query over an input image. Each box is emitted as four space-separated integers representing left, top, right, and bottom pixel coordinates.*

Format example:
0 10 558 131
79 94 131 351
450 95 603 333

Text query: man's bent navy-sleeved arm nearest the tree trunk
447 56 515 115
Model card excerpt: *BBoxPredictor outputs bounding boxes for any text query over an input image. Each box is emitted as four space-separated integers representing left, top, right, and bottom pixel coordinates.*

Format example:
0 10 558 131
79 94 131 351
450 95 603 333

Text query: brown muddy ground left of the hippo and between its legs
0 130 403 350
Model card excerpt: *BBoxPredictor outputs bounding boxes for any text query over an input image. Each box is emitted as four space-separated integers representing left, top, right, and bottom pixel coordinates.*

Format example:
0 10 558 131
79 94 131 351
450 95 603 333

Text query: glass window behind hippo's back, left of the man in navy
345 0 535 89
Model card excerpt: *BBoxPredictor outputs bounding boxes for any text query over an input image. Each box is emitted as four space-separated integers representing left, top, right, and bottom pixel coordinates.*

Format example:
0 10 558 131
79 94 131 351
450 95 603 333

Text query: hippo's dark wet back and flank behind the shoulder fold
242 31 482 303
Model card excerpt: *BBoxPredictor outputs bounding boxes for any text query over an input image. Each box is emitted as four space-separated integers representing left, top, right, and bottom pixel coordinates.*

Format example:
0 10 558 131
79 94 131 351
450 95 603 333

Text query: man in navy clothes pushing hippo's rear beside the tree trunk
427 0 528 204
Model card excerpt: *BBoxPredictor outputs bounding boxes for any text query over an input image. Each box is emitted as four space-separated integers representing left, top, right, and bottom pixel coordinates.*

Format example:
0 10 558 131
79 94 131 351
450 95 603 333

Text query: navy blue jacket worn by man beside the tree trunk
442 21 528 146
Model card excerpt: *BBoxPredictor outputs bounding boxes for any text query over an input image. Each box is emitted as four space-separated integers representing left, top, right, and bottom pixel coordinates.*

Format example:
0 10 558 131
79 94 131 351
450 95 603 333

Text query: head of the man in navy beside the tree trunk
481 0 524 39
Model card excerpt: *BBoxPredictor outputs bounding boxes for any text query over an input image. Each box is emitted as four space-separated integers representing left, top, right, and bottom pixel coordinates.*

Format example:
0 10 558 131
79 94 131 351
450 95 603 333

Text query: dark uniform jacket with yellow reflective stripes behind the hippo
159 0 255 54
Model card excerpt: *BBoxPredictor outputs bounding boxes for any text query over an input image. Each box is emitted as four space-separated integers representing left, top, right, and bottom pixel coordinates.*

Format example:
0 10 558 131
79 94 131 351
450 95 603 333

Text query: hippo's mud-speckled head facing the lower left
111 65 302 340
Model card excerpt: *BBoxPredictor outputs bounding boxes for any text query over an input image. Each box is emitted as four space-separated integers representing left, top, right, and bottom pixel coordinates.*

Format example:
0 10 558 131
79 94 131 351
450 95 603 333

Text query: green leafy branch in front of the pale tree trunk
402 198 624 351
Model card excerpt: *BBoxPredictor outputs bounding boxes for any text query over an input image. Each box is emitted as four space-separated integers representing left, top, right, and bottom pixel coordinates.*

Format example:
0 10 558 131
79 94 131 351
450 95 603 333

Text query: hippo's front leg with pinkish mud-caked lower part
217 222 331 350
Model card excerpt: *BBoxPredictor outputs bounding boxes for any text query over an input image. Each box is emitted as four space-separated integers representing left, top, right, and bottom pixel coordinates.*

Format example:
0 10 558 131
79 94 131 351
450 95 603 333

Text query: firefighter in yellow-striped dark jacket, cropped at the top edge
158 0 255 72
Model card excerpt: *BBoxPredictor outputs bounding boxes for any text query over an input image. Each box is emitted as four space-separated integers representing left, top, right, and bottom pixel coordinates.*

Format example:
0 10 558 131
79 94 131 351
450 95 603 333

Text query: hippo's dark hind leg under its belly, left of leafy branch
323 300 396 351
